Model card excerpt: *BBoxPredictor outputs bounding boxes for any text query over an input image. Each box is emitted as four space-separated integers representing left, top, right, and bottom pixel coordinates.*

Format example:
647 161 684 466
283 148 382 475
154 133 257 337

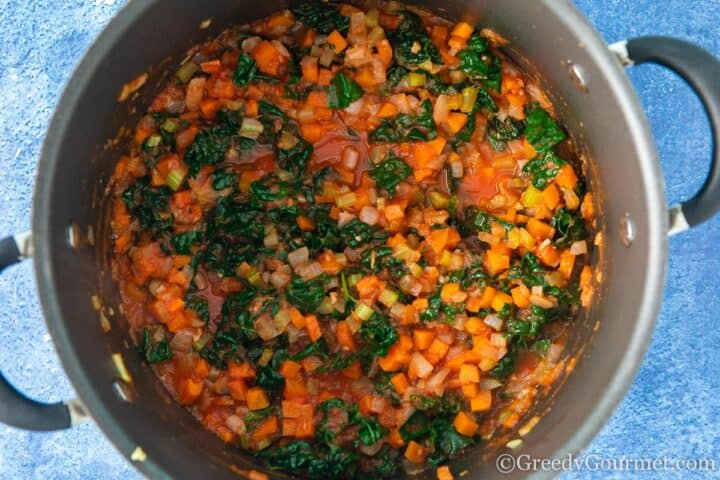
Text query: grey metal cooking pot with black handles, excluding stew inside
0 0 720 479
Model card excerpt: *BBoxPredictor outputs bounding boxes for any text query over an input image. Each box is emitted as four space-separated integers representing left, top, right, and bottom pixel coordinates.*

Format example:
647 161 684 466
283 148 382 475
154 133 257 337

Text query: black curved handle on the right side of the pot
610 37 720 235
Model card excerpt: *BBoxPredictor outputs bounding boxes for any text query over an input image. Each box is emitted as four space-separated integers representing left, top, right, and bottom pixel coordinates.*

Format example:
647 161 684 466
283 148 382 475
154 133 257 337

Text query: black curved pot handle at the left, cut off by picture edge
0 233 85 431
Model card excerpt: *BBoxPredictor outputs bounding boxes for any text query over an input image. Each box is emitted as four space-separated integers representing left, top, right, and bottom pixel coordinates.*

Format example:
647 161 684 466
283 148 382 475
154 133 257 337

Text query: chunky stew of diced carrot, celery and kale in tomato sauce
111 2 594 479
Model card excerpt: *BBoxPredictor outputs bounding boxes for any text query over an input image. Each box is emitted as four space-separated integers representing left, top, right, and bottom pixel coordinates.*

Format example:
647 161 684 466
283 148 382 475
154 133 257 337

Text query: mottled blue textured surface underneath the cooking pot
0 0 720 480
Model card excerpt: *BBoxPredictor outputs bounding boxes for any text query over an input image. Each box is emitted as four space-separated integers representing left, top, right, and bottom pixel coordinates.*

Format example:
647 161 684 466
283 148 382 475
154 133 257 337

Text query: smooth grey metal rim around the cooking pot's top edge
32 0 668 478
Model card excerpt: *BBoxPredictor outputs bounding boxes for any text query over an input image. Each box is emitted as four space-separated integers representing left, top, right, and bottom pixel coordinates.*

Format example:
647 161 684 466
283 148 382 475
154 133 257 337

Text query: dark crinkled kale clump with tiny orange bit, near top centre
388 10 443 67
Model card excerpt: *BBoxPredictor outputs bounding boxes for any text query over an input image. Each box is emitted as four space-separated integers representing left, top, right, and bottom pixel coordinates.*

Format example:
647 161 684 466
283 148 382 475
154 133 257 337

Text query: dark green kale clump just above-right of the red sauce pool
369 100 437 143
